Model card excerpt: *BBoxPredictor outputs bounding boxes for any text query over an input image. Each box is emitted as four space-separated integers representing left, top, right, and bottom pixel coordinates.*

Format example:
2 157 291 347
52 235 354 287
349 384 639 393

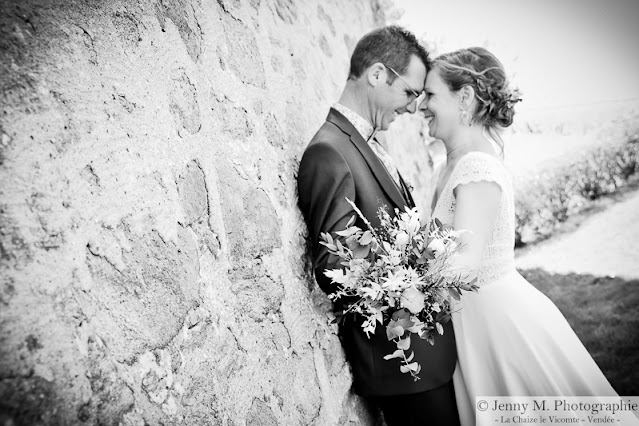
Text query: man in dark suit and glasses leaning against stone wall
297 26 459 426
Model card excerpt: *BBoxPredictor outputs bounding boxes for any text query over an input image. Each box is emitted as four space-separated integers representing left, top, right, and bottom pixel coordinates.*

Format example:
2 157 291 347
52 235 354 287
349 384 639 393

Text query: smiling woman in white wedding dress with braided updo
420 47 639 425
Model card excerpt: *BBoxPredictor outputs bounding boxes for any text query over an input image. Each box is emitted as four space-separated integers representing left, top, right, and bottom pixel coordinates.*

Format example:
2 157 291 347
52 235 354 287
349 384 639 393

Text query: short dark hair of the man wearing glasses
348 25 430 84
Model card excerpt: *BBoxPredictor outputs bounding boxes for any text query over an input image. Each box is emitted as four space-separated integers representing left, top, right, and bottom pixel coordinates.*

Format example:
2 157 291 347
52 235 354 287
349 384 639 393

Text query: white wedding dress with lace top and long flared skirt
433 152 639 426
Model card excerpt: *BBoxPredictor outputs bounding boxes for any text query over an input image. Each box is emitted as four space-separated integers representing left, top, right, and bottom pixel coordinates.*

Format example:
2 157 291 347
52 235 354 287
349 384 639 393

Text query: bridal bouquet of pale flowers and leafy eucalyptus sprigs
320 199 478 380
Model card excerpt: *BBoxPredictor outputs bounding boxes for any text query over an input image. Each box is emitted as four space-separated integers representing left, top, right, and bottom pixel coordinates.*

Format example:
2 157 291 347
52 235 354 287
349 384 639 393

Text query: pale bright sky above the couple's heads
393 0 639 110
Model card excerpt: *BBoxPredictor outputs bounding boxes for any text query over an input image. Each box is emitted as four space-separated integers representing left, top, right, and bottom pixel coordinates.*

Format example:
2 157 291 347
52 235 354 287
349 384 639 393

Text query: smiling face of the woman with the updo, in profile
419 69 460 142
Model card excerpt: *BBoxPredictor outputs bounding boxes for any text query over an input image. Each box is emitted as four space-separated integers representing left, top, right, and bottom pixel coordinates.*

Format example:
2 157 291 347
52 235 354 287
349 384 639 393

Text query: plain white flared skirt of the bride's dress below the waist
452 269 639 426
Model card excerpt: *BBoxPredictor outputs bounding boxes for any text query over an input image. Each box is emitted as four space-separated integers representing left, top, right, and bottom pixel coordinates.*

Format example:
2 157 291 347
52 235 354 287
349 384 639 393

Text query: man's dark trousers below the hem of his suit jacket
369 380 459 426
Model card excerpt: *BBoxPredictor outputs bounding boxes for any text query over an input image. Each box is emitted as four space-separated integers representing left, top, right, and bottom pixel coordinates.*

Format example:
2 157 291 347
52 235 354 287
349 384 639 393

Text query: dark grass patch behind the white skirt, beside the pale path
520 269 639 396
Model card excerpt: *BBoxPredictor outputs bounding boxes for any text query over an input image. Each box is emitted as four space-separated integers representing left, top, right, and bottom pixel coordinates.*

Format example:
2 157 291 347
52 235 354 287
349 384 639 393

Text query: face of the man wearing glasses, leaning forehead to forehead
371 56 426 130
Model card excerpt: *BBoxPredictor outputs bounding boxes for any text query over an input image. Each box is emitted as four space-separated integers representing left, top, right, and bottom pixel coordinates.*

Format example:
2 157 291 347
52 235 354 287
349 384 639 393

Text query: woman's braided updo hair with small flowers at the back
433 47 521 131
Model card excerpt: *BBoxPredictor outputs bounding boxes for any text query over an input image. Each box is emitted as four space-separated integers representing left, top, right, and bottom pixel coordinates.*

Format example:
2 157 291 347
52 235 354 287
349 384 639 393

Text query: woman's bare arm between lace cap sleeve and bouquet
453 181 501 275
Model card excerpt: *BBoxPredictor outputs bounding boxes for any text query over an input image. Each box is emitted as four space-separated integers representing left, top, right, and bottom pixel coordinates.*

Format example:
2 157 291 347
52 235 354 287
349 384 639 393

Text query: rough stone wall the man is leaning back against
0 0 414 426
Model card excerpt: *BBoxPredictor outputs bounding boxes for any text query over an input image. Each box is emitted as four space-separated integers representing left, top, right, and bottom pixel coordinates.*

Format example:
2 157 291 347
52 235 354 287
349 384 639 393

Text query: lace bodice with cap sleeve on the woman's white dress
433 152 515 286
